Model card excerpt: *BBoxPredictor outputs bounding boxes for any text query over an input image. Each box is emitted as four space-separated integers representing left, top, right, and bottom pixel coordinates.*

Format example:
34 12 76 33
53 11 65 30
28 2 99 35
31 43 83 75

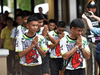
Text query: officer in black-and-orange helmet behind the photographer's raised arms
82 0 99 75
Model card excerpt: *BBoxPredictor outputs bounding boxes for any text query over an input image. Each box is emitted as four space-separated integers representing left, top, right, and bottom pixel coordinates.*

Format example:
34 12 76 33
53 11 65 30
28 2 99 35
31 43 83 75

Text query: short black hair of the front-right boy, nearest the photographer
70 18 84 29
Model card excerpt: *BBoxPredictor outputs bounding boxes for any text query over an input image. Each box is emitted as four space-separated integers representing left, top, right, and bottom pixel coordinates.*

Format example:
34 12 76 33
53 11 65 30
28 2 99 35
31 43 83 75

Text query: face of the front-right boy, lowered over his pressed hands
71 27 83 38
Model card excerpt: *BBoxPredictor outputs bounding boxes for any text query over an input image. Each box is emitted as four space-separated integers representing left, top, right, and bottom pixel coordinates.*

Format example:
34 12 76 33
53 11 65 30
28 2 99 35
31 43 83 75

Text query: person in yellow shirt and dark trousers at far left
0 17 15 75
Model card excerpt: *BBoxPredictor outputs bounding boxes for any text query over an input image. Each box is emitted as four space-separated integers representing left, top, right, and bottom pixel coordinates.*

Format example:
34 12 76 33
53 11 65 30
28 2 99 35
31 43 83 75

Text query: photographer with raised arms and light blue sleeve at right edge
82 11 100 75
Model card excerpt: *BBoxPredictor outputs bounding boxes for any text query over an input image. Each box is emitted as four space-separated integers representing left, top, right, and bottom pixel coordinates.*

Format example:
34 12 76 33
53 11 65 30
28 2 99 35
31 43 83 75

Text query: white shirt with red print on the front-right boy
60 35 90 70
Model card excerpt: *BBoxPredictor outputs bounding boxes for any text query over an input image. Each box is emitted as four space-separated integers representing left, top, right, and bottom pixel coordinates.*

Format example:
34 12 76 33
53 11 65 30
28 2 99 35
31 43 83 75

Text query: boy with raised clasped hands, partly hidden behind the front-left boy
33 13 56 75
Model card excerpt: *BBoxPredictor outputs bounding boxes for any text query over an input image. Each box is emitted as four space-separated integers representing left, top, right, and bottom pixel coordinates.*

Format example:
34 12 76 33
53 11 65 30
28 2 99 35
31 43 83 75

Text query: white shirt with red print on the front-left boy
16 34 47 66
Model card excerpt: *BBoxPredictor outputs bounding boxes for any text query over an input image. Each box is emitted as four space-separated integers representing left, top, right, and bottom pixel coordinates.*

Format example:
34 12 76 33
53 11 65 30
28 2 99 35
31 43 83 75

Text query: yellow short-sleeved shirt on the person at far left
1 26 14 50
